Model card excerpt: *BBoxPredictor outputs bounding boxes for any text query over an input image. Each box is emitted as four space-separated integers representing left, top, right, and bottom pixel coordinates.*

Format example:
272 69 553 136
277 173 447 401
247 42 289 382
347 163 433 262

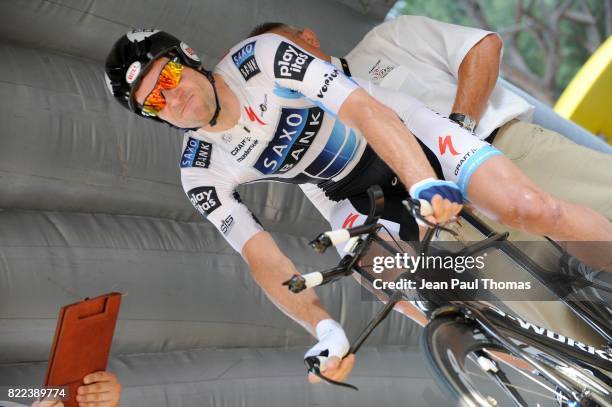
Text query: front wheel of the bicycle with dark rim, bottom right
421 317 612 407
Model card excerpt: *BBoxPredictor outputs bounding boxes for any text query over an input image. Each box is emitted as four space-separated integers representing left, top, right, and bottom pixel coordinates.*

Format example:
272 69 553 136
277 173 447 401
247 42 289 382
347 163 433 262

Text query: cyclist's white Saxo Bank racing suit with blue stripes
180 34 500 252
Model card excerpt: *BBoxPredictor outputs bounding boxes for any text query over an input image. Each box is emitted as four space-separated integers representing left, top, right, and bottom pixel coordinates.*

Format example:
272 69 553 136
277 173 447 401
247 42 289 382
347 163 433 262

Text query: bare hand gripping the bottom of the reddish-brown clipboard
77 372 121 407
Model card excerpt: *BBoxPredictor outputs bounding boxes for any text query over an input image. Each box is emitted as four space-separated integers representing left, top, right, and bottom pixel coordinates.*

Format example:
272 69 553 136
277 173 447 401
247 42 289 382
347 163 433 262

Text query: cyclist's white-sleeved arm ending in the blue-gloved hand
255 34 462 221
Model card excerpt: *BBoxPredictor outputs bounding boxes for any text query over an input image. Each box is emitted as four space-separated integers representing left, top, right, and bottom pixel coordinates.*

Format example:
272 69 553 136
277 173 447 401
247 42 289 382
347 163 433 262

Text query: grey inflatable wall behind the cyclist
0 0 605 407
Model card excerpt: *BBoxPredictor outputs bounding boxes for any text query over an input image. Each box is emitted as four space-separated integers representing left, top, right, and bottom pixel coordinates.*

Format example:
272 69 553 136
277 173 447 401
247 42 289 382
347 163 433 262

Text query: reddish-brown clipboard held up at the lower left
45 293 121 407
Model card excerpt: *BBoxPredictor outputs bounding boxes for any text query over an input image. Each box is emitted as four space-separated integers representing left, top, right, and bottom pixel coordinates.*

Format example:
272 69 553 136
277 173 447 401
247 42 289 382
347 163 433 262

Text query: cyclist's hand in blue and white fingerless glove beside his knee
410 178 463 223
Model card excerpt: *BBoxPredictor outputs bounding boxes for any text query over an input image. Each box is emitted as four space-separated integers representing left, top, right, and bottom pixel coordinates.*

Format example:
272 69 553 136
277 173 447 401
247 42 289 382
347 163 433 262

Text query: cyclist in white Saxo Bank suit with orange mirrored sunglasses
106 30 612 386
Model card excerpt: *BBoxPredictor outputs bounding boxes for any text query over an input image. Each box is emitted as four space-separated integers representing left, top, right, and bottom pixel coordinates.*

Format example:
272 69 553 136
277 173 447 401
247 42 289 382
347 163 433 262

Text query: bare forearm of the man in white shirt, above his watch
452 34 502 122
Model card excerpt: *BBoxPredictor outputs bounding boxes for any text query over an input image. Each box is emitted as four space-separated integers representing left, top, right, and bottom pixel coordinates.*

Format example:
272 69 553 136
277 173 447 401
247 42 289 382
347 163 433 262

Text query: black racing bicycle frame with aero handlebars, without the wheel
285 191 612 402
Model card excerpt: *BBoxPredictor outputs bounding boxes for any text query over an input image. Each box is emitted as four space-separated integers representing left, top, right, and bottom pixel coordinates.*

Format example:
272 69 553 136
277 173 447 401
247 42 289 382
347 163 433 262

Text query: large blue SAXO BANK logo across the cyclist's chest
254 107 323 174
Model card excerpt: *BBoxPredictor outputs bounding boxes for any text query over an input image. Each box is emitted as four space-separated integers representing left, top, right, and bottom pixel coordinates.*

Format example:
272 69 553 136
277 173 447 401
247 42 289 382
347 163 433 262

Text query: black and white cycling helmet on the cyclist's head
105 29 210 121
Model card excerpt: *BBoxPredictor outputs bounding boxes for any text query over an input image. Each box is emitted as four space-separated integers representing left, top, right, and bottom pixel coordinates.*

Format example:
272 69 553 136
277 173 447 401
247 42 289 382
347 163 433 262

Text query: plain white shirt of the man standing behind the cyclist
340 16 534 139
